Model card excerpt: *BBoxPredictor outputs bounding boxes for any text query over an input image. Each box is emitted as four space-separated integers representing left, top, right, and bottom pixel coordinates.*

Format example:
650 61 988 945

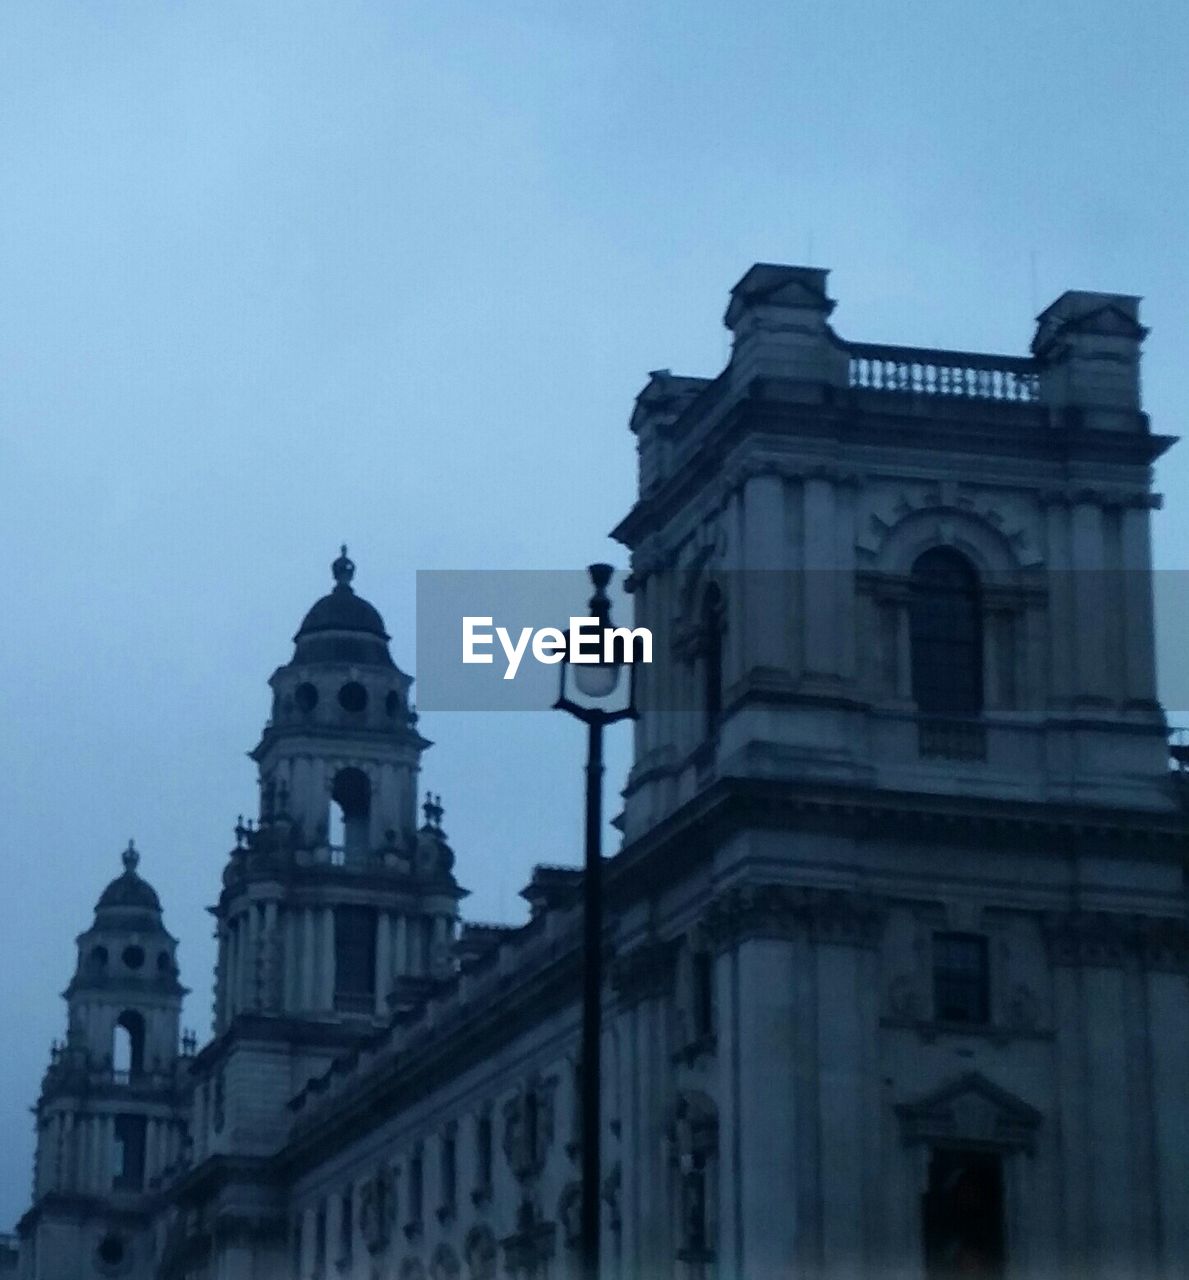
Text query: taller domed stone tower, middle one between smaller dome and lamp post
179 547 465 1274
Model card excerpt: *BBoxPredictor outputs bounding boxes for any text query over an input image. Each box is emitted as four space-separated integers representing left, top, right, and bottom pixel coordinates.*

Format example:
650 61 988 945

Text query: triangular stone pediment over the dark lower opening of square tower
896 1071 1042 1151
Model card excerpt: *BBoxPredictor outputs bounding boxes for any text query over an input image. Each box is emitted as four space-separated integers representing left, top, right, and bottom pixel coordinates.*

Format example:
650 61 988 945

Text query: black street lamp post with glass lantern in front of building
553 564 637 1280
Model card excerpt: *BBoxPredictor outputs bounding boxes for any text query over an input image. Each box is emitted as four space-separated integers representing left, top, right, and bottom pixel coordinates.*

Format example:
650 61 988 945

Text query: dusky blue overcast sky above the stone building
0 0 1189 1226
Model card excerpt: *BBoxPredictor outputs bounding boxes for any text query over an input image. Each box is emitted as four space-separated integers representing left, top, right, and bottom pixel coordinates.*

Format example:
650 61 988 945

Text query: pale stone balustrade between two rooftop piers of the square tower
846 342 1041 404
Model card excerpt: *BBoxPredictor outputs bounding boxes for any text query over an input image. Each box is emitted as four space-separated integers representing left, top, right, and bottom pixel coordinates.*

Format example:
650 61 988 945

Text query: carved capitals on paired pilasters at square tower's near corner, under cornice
706 884 884 951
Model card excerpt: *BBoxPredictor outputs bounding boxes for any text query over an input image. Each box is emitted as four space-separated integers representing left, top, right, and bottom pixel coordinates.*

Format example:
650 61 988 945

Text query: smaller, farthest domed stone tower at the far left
19 841 186 1280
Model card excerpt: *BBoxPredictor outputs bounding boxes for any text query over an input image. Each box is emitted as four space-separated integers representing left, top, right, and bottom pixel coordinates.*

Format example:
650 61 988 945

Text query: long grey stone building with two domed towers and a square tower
20 265 1189 1280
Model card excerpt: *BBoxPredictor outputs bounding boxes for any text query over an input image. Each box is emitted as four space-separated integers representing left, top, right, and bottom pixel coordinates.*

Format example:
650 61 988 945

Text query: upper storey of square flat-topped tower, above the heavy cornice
618 264 1171 838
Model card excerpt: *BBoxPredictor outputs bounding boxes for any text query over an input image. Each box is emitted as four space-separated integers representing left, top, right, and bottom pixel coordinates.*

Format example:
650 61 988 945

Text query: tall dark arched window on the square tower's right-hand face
910 547 983 717
